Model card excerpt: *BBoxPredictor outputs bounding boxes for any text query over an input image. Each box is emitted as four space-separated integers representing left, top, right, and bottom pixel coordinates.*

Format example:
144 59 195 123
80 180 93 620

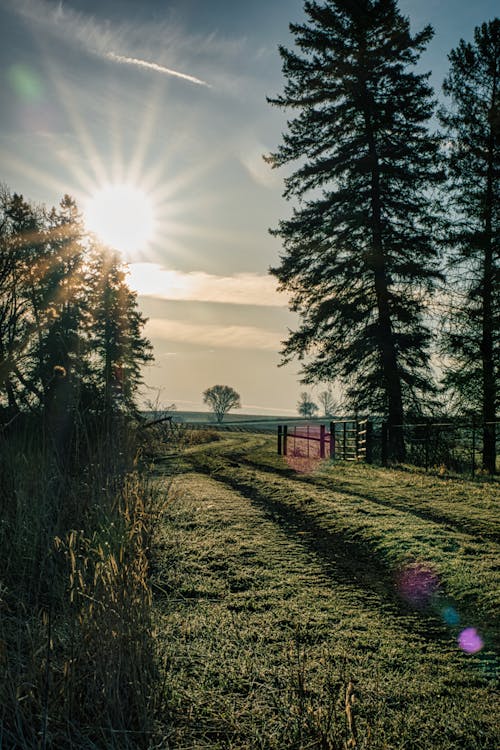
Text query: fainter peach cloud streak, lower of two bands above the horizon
145 318 281 351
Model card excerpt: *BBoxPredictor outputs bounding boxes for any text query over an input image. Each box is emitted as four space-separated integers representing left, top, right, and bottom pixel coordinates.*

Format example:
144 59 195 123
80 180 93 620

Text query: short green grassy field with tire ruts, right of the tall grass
153 435 500 750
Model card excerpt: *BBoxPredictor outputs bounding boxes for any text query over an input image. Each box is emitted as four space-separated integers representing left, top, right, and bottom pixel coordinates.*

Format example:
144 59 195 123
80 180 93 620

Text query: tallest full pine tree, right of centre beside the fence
268 0 441 459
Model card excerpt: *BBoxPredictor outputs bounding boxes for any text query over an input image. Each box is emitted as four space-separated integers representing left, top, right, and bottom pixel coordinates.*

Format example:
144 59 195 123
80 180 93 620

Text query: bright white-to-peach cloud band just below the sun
129 263 287 307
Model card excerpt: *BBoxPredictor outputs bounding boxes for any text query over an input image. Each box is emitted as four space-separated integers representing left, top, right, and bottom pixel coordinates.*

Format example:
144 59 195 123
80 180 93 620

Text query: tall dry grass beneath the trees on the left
0 414 170 750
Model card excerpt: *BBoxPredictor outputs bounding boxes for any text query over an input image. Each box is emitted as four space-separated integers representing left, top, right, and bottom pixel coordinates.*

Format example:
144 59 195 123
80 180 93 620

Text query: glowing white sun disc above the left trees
84 183 156 261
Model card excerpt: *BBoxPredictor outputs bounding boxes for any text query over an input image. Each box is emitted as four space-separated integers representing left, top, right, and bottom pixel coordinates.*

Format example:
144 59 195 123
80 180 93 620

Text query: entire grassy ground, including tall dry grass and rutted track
0 425 499 750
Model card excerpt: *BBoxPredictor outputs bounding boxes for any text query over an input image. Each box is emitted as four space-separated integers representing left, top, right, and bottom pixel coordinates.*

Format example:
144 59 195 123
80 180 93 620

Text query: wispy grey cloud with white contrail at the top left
13 0 210 86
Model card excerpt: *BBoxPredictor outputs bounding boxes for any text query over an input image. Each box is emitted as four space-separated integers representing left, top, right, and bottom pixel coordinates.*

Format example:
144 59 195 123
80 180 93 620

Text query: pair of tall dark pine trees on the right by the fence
267 0 500 472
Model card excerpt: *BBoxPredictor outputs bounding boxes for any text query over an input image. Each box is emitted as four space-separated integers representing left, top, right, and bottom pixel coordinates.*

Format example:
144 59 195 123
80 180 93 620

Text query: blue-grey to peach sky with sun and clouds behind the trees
0 0 498 415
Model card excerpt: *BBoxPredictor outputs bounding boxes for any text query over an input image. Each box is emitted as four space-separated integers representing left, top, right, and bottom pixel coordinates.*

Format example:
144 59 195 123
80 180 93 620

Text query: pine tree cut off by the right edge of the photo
440 18 500 473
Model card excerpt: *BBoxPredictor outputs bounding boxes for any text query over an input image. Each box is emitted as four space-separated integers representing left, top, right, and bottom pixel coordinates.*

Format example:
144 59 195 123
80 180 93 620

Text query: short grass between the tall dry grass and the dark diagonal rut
154 467 495 750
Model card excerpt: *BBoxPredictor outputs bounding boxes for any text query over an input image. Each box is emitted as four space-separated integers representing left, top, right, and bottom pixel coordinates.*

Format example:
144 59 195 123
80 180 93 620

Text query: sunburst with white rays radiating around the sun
6 24 217 264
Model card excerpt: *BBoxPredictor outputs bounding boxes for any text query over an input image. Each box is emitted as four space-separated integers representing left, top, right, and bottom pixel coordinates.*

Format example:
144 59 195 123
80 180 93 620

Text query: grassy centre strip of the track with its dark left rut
190 444 499 650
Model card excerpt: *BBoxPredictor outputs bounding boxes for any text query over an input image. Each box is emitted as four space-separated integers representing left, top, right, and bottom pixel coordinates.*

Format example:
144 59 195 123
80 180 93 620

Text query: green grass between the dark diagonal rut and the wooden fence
188 439 500 634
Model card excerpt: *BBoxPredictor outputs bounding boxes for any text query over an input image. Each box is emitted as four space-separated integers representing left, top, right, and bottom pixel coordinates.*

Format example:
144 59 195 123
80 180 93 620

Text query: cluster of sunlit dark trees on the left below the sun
0 186 152 438
